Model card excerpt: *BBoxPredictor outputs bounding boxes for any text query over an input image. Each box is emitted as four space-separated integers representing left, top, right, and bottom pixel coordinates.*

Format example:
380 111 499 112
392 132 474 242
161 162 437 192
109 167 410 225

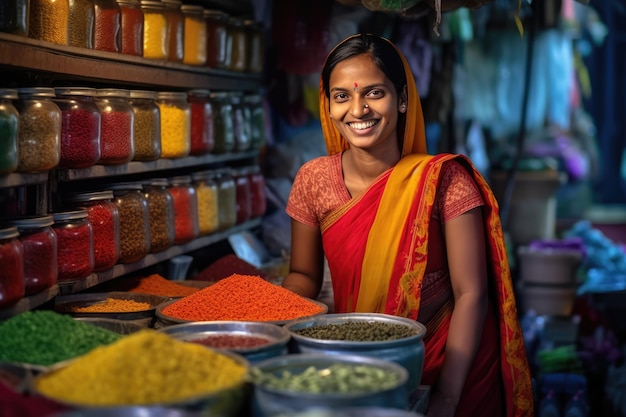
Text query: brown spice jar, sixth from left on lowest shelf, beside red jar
143 178 174 253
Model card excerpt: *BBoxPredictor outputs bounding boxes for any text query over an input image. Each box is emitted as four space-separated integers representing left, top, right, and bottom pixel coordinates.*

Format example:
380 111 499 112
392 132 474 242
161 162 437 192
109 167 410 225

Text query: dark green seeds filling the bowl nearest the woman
293 321 417 342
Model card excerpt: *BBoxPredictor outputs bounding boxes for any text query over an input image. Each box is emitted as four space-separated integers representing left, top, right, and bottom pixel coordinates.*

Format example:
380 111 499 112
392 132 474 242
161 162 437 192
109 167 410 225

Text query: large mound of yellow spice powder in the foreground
35 329 247 406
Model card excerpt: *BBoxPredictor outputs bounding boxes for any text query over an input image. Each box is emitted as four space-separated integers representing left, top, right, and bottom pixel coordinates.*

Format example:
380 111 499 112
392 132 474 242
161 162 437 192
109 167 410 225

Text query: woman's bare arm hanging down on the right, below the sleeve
435 207 488 404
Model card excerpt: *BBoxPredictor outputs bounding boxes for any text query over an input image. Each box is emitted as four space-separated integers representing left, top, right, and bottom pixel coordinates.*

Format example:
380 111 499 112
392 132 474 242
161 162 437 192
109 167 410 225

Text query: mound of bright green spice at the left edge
0 310 122 366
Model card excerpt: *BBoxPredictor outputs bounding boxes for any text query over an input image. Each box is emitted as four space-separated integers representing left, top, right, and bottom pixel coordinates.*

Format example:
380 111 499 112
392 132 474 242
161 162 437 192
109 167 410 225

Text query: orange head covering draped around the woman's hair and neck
319 34 426 156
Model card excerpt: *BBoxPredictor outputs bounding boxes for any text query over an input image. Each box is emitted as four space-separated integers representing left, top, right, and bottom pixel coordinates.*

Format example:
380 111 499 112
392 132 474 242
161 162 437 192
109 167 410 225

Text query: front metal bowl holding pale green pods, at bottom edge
252 353 408 416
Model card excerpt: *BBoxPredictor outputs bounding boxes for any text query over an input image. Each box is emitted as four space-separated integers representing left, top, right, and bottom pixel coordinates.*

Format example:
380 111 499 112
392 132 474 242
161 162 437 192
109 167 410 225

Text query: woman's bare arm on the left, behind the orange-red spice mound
282 219 324 299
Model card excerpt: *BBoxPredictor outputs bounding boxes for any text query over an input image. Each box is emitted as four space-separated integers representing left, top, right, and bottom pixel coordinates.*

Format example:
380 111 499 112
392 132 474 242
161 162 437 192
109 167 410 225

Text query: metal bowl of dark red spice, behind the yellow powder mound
158 321 291 364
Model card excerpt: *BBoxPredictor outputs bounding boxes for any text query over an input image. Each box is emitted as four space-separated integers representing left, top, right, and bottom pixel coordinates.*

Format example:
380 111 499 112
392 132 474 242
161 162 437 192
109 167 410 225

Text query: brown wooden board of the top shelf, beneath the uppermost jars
0 33 261 91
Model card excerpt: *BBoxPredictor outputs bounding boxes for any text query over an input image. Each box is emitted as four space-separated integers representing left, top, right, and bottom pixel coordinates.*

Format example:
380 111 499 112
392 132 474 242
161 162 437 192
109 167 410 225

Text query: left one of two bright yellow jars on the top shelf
140 0 170 60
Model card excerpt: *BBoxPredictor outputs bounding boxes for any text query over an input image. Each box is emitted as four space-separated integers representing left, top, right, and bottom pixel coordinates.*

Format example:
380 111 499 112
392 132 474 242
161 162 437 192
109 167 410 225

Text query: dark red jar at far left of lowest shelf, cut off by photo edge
0 226 25 308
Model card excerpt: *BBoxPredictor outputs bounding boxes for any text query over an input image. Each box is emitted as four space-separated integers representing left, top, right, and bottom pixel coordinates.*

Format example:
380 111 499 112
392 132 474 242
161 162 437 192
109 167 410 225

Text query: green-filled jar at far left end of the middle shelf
0 88 20 175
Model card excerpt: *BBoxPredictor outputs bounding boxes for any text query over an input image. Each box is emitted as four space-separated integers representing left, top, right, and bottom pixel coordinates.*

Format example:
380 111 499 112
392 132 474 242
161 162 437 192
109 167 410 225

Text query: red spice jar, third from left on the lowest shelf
52 210 95 282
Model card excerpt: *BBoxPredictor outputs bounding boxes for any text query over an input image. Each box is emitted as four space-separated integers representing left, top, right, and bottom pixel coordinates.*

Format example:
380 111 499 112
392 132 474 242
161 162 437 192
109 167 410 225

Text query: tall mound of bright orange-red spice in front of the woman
162 274 323 321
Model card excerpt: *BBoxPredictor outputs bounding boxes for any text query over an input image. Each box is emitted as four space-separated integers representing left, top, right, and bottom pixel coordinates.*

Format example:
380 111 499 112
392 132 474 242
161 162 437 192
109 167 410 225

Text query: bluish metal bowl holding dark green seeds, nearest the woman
285 313 426 391
